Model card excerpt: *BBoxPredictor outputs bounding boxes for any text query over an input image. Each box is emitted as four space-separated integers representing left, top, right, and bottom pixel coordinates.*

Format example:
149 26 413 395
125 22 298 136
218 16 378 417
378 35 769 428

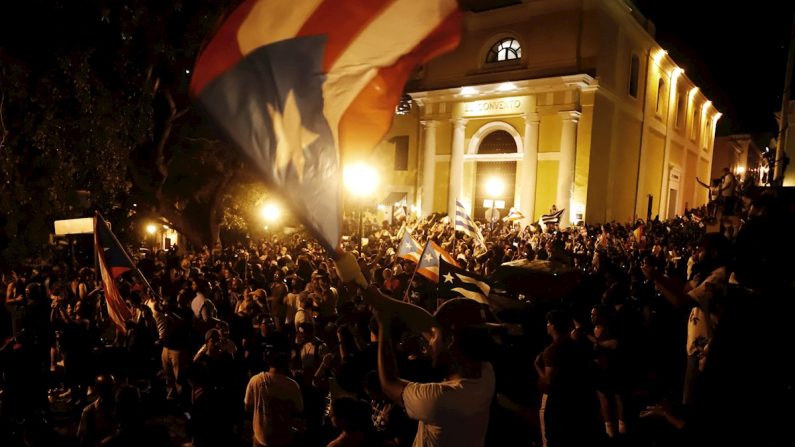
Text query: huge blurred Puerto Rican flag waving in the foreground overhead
190 0 461 250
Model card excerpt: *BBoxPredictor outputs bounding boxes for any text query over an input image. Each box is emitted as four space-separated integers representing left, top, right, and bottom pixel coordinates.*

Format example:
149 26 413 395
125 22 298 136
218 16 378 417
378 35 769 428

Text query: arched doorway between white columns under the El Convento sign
472 129 518 220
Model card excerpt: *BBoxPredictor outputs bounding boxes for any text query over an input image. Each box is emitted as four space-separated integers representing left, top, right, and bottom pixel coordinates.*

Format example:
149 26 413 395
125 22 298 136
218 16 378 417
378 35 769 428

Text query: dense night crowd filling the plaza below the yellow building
0 186 795 447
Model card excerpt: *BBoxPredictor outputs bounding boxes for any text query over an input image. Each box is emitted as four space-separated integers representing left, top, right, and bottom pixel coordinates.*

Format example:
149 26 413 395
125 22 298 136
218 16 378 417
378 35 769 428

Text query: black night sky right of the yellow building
635 0 795 135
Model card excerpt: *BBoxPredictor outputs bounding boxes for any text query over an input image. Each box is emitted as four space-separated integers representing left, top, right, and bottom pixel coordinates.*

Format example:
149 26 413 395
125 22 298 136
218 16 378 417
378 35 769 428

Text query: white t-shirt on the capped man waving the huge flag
403 363 495 447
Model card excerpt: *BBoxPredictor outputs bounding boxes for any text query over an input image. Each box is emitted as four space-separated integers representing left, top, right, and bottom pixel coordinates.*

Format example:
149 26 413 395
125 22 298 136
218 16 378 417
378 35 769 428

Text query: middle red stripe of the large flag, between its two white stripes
298 0 395 73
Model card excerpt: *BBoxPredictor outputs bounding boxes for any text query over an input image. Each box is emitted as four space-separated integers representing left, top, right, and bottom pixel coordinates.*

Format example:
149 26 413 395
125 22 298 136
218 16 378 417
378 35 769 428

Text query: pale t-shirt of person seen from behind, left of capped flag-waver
243 372 304 446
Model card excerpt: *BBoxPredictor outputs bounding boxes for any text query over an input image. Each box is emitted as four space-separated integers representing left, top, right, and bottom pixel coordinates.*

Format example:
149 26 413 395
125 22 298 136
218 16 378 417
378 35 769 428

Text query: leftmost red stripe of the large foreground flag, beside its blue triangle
190 0 259 96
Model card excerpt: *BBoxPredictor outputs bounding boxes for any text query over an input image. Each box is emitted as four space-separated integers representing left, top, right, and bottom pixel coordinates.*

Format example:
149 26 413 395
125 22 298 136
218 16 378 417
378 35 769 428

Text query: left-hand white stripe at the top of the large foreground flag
237 0 323 55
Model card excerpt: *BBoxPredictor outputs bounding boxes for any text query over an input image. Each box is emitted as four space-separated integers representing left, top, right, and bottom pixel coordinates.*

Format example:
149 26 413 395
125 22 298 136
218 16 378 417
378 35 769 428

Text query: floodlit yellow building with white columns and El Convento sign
374 0 720 224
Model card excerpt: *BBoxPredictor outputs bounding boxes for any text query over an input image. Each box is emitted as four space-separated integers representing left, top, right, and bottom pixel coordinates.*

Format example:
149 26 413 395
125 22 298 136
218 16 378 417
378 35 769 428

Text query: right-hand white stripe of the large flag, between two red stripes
324 0 457 144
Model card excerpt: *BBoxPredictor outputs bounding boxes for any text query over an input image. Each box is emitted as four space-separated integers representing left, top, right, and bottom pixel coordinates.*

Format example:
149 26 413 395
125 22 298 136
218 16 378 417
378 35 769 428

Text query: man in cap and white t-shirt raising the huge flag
368 286 495 447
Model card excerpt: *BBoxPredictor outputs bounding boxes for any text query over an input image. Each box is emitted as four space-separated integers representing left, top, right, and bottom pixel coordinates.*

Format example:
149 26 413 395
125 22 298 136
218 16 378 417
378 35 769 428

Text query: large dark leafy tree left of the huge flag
0 0 250 258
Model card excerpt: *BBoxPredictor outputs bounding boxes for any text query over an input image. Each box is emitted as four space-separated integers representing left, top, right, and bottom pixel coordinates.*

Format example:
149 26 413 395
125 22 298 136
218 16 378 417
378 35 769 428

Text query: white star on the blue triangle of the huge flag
268 90 318 180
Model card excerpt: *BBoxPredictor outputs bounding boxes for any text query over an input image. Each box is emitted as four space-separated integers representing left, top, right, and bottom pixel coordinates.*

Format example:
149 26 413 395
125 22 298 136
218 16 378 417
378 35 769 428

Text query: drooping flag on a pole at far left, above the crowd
94 213 137 333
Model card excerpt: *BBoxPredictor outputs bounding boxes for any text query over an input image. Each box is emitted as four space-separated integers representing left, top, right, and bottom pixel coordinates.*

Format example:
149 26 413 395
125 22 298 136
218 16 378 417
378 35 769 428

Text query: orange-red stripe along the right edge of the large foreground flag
339 11 463 158
